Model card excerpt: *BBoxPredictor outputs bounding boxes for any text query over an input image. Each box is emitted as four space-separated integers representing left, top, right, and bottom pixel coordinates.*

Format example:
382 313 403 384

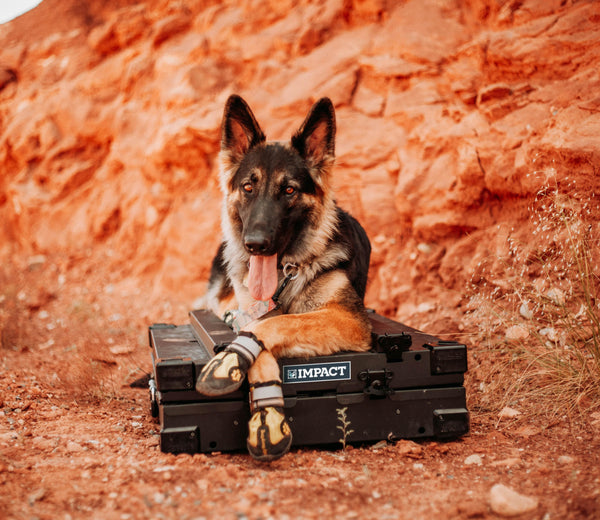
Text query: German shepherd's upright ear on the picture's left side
221 94 265 163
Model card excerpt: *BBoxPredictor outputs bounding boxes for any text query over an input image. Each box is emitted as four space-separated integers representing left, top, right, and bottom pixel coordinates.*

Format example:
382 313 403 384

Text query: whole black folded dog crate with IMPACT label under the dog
149 310 469 453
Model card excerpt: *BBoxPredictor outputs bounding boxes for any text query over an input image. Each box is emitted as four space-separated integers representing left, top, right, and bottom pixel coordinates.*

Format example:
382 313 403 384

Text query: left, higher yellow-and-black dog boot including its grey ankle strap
196 332 265 396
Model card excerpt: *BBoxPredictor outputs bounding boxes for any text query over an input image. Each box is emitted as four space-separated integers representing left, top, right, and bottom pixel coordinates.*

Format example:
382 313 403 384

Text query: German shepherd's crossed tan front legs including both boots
196 303 370 461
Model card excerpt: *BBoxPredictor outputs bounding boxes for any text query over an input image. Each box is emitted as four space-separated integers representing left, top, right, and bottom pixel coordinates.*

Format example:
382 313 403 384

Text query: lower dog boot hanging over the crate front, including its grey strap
246 381 292 462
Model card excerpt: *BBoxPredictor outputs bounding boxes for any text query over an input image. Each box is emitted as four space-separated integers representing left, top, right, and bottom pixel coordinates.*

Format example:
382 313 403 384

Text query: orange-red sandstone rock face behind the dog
0 0 600 317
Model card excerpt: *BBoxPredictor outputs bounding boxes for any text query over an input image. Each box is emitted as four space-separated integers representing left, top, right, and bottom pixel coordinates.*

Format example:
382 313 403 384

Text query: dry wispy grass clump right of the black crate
471 181 600 419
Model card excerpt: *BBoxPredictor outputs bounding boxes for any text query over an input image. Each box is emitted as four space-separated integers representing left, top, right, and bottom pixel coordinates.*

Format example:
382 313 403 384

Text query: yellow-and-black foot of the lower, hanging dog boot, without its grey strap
246 406 292 462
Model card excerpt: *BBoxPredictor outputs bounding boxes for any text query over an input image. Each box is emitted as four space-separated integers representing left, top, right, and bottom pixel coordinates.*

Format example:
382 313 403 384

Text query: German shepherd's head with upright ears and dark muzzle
220 95 335 296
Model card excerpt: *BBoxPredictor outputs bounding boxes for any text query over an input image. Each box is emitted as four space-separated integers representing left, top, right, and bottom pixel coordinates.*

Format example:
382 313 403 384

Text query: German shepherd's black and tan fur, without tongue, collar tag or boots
199 95 370 460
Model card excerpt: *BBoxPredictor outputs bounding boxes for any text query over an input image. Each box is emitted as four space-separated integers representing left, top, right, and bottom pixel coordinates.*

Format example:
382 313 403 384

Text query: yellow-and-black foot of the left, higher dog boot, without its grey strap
196 351 249 396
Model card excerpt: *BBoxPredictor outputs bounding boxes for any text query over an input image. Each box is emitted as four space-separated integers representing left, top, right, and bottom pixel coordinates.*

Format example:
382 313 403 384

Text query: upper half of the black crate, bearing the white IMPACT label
150 311 467 401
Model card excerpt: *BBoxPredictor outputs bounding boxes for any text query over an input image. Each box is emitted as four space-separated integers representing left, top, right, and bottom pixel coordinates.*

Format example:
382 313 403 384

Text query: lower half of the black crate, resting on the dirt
156 387 469 452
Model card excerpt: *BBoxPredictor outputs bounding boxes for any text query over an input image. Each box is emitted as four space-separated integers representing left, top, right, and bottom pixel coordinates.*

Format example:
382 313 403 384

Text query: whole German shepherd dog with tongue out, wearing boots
196 95 371 461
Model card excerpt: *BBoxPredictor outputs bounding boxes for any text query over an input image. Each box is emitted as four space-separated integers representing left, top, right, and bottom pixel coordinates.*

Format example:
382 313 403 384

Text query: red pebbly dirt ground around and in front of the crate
0 254 600 519
